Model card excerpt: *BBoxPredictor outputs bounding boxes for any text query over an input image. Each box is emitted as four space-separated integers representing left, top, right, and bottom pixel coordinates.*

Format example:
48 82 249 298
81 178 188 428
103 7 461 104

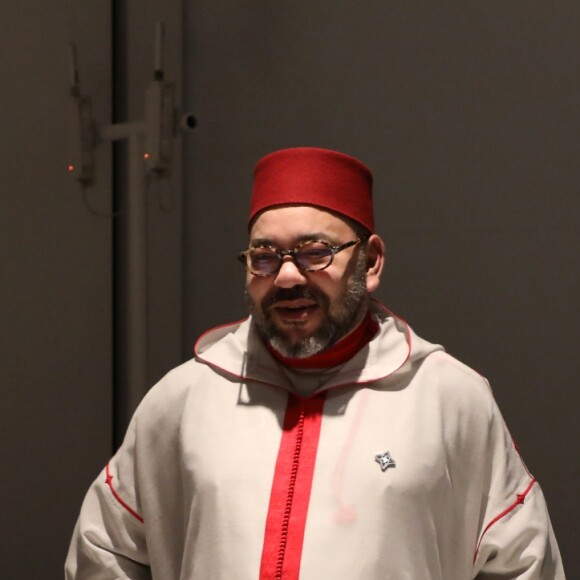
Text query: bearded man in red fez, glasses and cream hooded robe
66 148 564 580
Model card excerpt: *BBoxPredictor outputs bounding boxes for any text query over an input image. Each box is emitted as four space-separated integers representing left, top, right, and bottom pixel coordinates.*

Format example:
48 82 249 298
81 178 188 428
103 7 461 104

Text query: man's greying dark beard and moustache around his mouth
246 252 368 358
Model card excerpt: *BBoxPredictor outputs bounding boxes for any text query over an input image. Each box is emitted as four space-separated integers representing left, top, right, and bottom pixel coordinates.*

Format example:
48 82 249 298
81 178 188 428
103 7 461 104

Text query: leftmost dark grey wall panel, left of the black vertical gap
0 0 112 580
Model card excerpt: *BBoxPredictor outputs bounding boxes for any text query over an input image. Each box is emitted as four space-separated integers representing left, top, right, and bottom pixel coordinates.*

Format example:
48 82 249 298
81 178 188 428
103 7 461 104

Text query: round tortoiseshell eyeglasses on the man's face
238 238 362 276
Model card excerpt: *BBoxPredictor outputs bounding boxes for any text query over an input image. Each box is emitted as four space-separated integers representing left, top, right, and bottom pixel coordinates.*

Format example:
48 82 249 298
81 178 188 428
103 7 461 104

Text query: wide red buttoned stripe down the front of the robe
259 394 325 580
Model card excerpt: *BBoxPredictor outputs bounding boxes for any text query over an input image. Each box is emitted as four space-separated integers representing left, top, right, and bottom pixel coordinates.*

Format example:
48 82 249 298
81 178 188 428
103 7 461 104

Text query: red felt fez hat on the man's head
249 147 375 232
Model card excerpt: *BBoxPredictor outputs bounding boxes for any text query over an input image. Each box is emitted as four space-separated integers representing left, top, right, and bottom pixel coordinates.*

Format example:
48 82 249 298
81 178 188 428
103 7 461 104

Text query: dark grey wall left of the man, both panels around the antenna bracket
0 0 182 580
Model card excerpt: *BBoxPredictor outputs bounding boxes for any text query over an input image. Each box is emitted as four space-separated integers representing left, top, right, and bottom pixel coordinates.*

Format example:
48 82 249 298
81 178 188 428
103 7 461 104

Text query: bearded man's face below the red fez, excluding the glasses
246 206 368 358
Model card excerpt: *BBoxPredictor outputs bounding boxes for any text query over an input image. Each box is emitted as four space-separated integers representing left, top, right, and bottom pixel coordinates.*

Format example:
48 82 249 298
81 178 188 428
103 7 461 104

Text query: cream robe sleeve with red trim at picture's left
65 424 151 580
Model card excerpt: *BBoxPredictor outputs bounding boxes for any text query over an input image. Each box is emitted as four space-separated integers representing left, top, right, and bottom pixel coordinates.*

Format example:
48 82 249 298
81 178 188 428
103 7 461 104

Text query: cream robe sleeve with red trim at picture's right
473 392 565 580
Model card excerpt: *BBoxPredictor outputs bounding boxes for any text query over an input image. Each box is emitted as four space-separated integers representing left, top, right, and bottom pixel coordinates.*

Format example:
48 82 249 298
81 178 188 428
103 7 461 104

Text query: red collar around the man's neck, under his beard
266 312 379 369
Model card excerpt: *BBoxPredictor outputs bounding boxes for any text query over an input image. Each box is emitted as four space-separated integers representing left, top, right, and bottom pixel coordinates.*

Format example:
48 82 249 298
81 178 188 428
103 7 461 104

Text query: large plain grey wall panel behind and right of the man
185 0 580 573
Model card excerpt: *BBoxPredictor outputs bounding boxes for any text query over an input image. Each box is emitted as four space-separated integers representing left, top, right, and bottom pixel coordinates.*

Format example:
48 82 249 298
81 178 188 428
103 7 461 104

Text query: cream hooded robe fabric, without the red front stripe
65 305 564 580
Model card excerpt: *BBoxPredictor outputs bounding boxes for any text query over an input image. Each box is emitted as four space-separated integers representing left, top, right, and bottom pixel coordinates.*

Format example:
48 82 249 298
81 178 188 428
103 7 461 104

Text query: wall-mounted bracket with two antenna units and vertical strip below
69 24 196 419
